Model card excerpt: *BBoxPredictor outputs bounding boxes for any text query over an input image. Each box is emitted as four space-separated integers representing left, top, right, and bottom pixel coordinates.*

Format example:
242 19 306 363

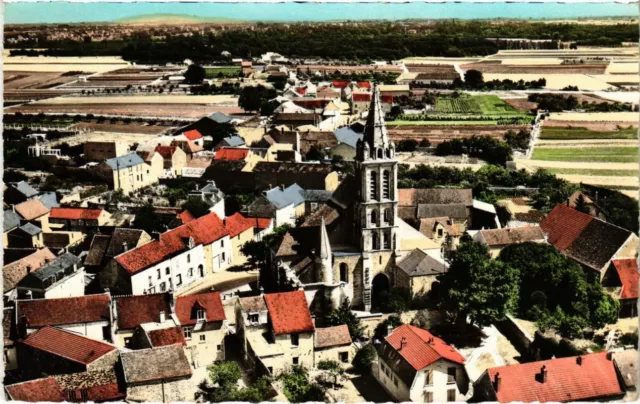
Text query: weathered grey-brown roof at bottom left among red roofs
120 345 192 384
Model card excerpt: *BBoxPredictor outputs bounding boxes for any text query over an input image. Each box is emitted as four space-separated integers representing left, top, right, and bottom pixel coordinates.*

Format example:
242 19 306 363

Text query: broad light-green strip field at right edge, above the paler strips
531 147 638 163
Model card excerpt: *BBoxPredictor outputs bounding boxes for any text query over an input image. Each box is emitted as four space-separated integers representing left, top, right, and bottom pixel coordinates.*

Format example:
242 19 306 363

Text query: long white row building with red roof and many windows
100 213 233 295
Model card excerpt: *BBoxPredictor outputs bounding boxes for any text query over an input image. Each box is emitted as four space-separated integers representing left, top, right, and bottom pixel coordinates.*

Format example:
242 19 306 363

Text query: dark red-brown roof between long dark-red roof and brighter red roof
113 293 171 329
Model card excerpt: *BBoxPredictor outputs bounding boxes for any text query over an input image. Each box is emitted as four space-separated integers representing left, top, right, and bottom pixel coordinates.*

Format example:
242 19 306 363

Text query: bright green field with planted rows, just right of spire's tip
436 95 527 117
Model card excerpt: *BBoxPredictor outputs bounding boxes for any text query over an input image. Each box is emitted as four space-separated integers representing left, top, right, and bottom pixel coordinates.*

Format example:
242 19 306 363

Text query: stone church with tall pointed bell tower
272 86 441 314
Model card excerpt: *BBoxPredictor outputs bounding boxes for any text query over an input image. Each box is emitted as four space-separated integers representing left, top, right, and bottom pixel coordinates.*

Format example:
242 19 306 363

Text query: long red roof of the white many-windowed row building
116 213 228 275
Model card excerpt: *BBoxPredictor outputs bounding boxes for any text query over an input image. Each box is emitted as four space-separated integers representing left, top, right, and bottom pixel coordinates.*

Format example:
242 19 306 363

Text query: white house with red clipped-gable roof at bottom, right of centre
373 324 473 403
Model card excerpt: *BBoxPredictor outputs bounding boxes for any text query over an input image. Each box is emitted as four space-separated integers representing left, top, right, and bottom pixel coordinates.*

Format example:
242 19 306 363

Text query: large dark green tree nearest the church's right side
440 239 518 326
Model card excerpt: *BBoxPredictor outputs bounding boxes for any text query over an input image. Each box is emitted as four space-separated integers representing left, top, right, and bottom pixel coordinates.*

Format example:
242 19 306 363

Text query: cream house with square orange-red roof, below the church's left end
236 290 315 375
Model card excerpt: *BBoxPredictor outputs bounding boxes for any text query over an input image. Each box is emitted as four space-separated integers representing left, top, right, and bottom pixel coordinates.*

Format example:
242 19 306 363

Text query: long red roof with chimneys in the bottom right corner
487 352 623 403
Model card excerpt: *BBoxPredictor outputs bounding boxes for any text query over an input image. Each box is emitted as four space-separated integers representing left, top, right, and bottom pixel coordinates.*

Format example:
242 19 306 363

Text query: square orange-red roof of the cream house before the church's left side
264 290 314 335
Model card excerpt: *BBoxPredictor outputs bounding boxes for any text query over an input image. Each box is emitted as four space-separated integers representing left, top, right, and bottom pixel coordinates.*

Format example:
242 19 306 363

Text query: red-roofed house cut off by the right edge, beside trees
602 258 640 317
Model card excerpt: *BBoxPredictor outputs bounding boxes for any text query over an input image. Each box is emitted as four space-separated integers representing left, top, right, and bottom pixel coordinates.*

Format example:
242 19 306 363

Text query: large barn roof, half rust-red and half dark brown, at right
540 205 632 271
